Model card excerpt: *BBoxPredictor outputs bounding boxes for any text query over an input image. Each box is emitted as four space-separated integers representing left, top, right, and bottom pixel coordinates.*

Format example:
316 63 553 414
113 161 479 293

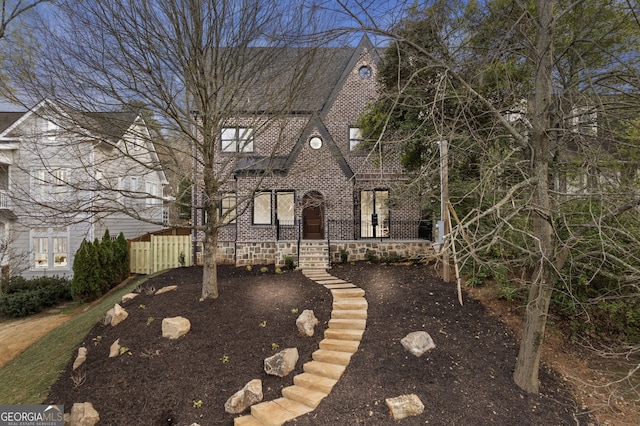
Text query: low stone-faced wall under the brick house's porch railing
212 240 433 266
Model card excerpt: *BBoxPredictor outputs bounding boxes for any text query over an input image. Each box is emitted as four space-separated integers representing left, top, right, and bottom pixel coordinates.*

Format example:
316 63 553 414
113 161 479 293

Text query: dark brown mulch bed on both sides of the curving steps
46 262 589 426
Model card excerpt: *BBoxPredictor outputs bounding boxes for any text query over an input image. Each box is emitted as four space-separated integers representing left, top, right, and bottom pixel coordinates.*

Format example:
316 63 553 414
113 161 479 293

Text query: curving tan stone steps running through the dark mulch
234 269 368 426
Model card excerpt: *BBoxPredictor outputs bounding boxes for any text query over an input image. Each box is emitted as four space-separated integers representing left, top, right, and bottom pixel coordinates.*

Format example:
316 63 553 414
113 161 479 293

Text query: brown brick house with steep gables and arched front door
193 37 430 267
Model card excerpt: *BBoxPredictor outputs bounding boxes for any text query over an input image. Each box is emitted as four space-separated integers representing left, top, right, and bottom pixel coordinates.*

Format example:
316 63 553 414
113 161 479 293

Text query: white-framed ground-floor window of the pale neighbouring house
31 227 69 269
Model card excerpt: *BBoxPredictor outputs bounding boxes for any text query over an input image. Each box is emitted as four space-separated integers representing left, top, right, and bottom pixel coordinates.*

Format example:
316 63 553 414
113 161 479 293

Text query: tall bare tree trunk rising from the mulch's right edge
513 0 557 393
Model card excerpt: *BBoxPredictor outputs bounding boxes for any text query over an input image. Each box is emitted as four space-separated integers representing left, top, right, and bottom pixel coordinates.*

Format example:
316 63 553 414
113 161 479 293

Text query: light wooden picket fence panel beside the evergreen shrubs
129 235 193 275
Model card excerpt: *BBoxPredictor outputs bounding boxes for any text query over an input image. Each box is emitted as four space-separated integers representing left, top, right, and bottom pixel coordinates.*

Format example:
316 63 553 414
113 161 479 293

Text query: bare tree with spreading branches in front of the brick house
6 0 340 299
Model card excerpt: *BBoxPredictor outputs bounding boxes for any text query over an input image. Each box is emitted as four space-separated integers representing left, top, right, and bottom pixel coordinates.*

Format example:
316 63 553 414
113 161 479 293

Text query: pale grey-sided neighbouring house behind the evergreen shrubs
0 100 166 278
